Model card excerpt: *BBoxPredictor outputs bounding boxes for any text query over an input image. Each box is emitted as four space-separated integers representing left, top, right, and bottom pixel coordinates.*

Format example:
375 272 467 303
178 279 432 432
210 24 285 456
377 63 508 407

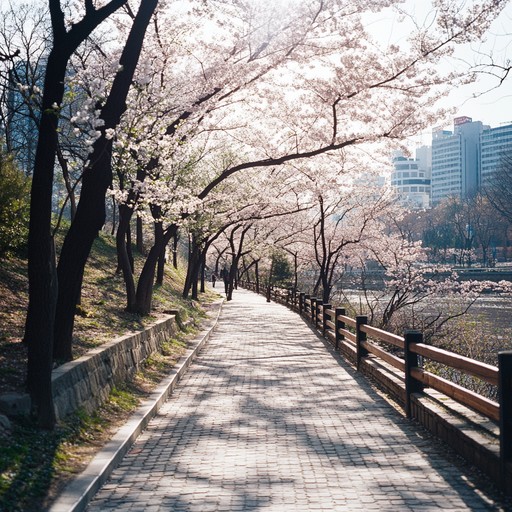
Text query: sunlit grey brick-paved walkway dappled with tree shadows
87 290 504 512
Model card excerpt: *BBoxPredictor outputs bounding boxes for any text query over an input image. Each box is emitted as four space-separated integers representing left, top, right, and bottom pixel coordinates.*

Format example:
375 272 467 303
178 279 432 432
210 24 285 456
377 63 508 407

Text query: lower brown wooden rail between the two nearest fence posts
411 368 500 421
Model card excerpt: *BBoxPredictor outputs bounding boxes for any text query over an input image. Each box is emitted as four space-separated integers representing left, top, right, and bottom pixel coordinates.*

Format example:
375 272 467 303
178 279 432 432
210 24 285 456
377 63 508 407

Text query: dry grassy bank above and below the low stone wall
0 233 218 512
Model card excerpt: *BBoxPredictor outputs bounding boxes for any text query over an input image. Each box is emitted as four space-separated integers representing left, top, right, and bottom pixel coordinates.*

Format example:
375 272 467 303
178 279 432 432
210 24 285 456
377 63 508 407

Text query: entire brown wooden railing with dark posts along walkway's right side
241 282 512 492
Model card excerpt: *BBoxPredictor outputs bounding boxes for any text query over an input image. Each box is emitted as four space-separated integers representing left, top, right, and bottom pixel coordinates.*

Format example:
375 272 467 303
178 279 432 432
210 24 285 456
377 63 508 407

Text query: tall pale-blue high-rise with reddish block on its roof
432 117 484 205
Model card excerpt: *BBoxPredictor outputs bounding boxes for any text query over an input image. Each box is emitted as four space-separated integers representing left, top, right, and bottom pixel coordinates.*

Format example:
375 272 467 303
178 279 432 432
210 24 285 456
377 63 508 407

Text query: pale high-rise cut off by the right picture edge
480 124 512 187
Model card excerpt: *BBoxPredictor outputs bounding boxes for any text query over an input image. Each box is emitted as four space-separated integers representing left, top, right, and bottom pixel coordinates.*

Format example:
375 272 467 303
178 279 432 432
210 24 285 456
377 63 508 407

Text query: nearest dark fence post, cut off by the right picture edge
498 350 512 493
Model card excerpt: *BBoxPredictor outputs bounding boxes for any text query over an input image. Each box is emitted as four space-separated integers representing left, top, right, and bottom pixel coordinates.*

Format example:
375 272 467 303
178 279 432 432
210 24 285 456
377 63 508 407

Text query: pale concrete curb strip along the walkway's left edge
48 301 223 512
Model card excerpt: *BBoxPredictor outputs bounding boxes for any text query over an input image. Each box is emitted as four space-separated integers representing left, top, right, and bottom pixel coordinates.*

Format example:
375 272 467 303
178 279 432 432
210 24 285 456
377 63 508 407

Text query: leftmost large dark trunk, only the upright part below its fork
24 45 73 429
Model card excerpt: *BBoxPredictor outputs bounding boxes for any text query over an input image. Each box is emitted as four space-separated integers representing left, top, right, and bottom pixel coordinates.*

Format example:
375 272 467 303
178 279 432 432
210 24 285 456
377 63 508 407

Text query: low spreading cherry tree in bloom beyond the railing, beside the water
336 213 512 340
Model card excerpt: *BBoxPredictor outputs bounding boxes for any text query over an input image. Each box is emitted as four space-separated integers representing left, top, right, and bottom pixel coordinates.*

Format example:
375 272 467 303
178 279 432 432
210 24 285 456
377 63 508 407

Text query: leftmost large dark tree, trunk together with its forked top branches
25 0 126 427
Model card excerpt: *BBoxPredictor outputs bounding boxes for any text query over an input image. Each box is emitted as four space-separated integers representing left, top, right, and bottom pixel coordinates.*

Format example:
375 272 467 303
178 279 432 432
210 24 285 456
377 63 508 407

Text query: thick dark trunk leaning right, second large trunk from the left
55 0 158 359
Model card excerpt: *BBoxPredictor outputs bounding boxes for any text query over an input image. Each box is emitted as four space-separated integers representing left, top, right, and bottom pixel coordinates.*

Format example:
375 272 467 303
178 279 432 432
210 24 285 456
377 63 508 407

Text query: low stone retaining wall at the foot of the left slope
52 315 179 419
